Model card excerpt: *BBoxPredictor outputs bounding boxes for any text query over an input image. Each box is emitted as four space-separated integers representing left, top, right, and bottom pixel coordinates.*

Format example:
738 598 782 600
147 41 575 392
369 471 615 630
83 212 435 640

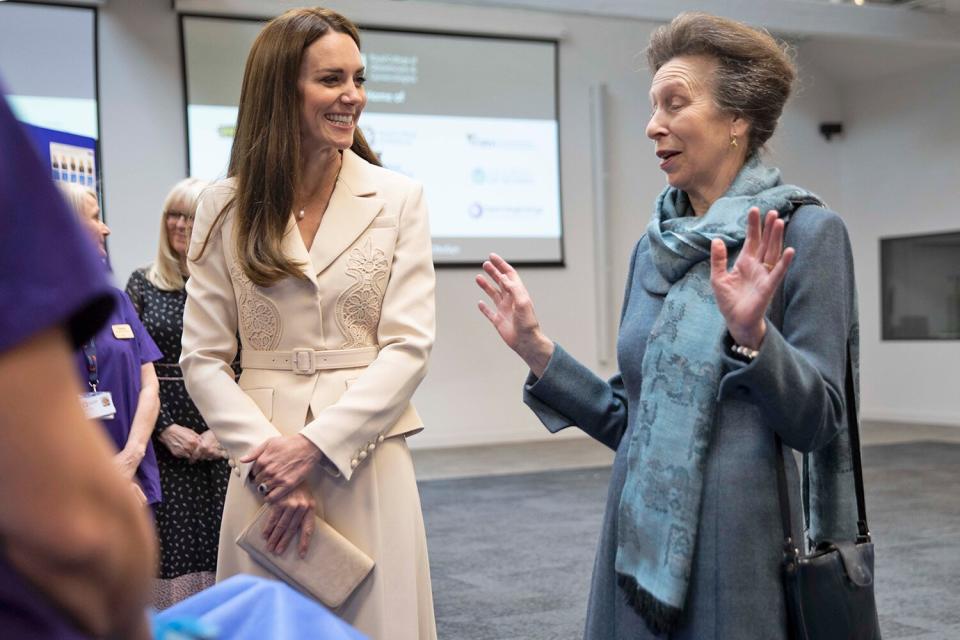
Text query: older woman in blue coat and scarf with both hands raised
477 13 857 640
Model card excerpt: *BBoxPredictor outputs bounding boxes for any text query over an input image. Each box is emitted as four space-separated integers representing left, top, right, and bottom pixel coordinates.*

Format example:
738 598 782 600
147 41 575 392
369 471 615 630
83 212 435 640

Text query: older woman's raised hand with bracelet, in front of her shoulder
710 207 794 349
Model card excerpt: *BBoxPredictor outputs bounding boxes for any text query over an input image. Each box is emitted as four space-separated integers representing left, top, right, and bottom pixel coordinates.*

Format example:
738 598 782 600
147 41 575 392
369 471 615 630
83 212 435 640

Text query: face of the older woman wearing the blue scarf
647 56 747 208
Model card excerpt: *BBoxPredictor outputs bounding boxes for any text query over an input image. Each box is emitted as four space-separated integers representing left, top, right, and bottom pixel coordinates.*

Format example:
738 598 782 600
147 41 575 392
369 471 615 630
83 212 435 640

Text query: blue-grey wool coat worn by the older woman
524 206 857 640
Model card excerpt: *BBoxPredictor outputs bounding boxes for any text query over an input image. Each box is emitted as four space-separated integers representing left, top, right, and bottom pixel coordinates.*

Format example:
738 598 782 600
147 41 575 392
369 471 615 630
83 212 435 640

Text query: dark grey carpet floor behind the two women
420 442 960 640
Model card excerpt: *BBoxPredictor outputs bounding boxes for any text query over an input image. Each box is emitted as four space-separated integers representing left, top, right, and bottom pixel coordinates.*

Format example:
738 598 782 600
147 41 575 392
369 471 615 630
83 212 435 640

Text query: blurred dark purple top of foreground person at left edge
0 86 113 640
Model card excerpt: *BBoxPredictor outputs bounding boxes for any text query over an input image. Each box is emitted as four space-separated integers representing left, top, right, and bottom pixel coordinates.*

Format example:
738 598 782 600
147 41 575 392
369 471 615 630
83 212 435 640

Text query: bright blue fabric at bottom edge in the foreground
153 575 367 640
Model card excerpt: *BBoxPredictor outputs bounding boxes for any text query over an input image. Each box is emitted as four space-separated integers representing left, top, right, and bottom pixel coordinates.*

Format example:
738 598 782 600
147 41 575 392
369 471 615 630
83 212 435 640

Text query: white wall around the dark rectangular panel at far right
839 61 960 426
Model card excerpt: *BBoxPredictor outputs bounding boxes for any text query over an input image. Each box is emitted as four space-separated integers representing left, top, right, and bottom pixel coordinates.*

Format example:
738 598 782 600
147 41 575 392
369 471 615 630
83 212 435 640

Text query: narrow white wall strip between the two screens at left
98 0 186 288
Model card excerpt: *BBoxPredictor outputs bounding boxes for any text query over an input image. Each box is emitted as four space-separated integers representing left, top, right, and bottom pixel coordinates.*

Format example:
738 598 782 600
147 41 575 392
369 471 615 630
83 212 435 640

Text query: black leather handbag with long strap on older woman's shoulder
775 345 880 640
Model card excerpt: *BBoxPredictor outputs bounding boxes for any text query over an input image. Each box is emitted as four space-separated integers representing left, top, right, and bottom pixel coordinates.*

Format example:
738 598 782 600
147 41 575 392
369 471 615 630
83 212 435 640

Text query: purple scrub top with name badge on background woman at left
75 289 163 504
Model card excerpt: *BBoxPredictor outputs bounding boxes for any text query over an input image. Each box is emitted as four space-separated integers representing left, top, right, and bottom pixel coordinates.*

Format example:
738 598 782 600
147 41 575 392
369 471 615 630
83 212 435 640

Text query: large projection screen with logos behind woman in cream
181 14 563 265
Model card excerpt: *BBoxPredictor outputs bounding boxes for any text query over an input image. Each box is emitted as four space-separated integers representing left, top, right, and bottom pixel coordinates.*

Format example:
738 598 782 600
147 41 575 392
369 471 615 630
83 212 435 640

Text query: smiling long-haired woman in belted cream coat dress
181 9 436 640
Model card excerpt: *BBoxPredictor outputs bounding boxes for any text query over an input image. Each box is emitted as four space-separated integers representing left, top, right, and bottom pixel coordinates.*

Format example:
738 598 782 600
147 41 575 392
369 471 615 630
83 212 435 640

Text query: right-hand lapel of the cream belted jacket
306 149 384 280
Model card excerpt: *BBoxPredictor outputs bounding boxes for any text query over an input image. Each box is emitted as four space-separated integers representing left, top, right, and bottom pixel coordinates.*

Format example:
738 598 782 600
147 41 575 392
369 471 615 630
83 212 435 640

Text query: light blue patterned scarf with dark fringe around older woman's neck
616 156 815 632
